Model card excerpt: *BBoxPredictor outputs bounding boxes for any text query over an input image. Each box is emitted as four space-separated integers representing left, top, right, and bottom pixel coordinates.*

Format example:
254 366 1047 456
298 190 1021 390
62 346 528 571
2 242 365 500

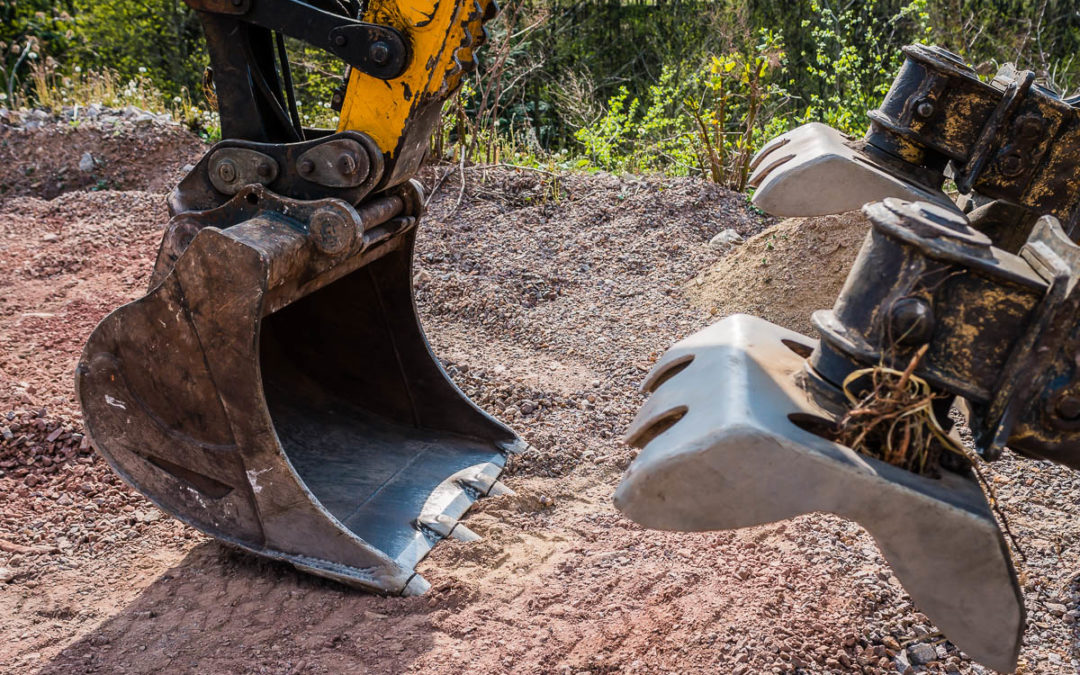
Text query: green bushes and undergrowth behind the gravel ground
0 0 1080 184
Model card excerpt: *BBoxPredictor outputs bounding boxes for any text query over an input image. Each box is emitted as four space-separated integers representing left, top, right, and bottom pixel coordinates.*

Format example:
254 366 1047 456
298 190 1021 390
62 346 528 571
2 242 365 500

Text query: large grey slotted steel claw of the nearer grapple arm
615 315 1024 671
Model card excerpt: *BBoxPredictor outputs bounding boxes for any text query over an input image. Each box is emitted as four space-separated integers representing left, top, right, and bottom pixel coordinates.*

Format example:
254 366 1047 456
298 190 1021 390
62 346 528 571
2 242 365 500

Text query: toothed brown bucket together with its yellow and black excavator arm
77 0 509 594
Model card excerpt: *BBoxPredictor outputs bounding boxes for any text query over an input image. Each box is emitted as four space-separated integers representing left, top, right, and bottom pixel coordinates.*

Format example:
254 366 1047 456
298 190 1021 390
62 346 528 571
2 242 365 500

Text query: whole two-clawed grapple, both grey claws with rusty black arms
616 45 1080 671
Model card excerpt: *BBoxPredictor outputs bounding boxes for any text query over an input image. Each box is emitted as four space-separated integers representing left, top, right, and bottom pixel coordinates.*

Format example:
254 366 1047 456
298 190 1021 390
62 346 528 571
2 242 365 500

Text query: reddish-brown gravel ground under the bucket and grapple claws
0 122 1080 675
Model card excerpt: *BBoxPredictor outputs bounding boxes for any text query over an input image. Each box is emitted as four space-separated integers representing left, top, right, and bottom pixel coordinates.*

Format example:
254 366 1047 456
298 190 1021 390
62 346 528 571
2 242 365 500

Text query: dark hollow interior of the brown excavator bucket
259 245 514 558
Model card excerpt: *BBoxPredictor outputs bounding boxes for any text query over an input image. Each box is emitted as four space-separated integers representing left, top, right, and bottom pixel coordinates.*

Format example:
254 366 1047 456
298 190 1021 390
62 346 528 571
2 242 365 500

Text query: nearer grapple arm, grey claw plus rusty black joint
616 199 1080 671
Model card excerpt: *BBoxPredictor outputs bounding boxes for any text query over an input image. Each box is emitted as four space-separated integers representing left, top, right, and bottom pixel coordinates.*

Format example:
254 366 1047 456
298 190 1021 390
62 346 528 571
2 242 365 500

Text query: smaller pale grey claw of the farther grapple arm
748 122 956 217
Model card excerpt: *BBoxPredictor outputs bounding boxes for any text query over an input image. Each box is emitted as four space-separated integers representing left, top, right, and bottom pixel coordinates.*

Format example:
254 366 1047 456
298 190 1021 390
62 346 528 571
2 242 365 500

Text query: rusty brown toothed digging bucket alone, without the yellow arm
77 184 524 594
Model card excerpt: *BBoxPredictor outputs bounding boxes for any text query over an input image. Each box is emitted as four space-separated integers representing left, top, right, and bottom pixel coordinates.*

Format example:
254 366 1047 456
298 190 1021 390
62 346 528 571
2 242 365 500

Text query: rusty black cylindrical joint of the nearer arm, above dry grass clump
810 200 1080 469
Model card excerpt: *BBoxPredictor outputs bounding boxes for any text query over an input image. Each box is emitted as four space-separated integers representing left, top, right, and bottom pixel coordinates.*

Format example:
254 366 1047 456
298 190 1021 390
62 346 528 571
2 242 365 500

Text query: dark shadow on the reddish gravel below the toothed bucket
40 541 433 675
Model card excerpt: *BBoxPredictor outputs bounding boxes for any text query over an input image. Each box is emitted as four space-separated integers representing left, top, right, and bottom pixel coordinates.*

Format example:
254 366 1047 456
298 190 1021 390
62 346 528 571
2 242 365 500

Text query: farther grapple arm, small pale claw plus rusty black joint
750 44 1080 243
